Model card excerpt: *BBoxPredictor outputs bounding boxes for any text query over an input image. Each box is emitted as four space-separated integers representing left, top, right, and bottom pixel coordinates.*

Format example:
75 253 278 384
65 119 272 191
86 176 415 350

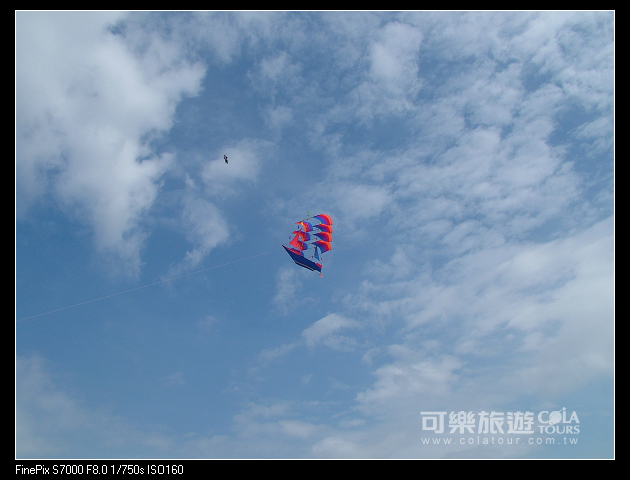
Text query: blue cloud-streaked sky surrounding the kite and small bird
15 11 615 458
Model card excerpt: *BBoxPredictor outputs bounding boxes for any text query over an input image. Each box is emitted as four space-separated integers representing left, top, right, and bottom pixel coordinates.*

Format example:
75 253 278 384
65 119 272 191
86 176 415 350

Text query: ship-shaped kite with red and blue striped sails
282 213 332 276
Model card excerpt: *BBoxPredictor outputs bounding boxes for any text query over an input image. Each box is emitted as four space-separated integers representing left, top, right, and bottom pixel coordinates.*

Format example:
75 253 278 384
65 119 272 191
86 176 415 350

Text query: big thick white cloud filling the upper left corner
16 12 204 275
